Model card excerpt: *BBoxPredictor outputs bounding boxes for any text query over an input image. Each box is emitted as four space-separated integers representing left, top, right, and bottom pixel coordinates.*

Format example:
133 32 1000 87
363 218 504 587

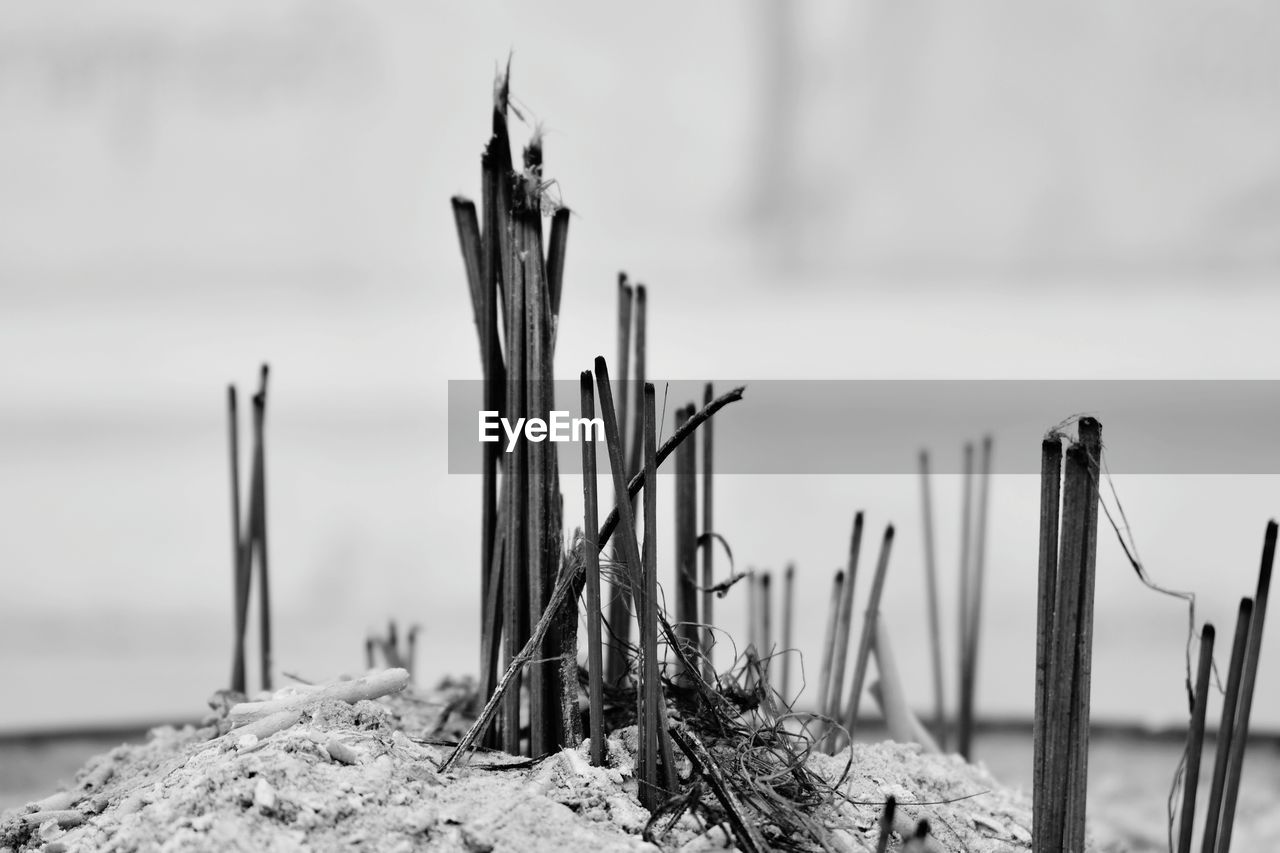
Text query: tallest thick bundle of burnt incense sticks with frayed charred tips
453 67 576 754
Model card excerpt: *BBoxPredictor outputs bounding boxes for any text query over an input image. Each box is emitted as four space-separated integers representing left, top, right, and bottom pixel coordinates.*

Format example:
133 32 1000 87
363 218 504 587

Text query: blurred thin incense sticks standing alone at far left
227 364 271 693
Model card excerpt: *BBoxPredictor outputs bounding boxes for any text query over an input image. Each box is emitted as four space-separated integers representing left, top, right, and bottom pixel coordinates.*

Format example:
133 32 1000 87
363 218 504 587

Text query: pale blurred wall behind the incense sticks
0 0 1280 758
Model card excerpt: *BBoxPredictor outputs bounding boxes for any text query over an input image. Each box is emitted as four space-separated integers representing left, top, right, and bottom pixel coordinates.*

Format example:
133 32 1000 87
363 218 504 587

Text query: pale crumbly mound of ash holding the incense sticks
0 685 1117 853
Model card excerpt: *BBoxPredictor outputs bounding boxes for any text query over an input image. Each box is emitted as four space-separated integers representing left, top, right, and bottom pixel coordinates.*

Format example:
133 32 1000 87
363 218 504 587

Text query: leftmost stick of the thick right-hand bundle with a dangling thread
1032 435 1062 850
